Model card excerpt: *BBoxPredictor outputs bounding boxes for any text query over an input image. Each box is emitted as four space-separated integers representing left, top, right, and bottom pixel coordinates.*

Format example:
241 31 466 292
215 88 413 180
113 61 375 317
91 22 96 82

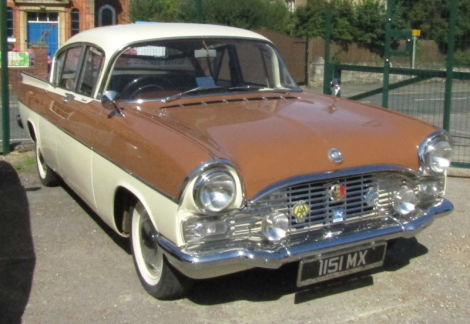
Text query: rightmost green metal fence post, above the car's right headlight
443 0 458 131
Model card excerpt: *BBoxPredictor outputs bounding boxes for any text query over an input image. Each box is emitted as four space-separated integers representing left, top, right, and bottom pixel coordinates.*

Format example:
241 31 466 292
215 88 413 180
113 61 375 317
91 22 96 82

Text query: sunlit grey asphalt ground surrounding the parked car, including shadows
0 153 470 323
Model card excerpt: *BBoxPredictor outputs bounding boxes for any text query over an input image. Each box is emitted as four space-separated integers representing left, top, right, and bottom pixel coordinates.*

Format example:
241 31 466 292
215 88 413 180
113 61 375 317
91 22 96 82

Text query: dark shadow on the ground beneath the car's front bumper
186 238 428 305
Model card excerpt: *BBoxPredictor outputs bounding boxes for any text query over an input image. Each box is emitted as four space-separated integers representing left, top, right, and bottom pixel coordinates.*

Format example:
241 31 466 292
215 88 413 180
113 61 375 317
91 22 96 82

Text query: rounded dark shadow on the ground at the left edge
0 161 36 323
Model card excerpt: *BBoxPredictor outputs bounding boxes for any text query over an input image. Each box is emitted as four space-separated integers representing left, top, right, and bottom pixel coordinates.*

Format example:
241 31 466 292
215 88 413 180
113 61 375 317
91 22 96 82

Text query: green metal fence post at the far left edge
0 1 10 155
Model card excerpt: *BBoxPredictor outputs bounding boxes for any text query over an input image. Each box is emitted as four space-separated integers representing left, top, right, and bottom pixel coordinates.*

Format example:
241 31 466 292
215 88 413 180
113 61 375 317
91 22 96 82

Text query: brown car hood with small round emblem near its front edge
151 93 435 198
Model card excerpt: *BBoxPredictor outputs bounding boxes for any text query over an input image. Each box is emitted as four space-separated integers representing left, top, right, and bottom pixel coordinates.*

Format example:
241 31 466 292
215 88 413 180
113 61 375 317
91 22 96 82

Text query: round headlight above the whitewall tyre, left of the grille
194 169 236 213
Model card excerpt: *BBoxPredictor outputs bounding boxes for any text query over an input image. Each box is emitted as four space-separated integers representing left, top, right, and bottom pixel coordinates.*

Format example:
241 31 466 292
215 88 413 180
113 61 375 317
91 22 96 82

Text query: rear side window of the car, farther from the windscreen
56 46 82 91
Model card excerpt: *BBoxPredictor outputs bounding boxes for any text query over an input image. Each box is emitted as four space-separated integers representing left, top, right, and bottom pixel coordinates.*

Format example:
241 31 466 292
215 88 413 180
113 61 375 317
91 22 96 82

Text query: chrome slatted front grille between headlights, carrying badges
255 174 405 232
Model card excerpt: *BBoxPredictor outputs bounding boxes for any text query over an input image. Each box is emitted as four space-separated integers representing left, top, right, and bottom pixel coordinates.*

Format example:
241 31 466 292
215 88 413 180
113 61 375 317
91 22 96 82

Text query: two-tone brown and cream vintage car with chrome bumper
19 23 453 299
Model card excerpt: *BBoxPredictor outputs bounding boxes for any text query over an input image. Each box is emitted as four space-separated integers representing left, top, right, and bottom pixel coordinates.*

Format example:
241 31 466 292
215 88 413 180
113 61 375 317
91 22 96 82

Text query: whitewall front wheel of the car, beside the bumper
130 202 189 299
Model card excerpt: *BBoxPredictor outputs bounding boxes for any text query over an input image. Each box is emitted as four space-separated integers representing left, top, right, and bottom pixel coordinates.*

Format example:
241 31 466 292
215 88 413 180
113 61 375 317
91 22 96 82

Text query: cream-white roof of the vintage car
64 23 269 55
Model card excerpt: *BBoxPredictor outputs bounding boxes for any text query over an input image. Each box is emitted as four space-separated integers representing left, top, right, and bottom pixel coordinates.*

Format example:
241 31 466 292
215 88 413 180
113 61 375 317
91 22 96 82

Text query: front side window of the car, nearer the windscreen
77 46 104 96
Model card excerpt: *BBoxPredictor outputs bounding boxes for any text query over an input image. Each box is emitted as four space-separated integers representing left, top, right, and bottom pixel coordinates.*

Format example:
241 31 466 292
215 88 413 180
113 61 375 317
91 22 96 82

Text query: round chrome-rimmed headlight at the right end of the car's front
420 133 452 174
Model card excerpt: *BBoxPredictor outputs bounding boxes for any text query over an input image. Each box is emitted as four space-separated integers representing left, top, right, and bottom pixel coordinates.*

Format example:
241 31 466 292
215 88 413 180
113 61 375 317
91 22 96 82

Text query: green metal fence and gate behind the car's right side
323 0 470 168
